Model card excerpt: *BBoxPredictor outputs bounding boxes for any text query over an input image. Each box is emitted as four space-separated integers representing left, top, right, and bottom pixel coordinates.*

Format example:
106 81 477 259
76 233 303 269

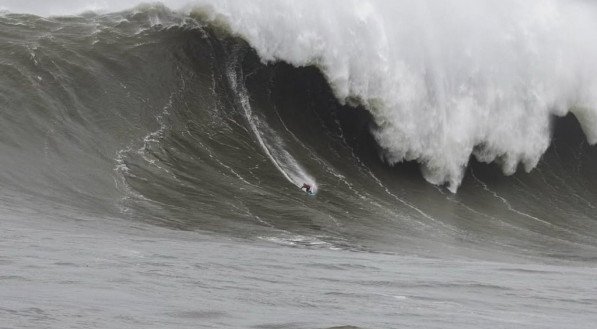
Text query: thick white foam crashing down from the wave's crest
190 0 597 191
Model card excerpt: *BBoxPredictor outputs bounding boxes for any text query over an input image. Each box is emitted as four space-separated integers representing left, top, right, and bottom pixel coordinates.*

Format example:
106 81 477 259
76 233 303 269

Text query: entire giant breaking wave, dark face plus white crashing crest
0 2 597 260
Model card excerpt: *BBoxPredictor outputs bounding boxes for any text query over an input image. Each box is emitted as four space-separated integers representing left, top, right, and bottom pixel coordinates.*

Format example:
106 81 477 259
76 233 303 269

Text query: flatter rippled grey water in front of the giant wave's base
0 213 597 328
